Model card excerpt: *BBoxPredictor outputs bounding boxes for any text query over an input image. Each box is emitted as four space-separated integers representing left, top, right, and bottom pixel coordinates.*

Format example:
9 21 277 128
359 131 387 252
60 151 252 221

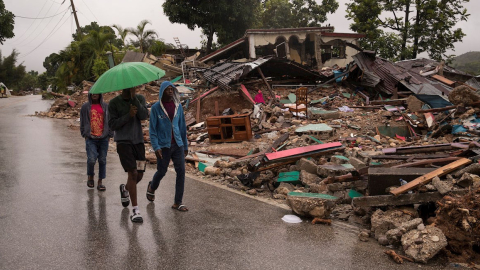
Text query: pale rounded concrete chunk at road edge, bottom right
402 226 447 263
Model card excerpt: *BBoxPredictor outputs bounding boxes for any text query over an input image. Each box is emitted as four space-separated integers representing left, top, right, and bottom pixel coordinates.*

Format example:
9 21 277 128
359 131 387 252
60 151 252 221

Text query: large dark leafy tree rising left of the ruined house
162 0 261 53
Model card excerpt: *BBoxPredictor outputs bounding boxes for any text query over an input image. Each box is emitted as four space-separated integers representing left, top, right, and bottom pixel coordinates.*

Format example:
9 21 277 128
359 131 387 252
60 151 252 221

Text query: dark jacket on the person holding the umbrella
108 95 148 144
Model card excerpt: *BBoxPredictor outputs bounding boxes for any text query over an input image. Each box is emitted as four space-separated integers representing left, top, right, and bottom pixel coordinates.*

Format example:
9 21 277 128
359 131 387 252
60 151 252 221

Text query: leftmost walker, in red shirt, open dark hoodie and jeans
80 94 113 191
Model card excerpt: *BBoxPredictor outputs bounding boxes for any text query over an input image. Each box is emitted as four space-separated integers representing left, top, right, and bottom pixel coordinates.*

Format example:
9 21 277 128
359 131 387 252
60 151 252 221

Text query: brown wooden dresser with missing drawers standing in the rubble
207 114 252 143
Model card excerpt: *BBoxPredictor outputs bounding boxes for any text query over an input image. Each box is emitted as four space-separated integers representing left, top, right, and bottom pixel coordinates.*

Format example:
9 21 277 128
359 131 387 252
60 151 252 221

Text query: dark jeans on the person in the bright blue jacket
150 143 185 204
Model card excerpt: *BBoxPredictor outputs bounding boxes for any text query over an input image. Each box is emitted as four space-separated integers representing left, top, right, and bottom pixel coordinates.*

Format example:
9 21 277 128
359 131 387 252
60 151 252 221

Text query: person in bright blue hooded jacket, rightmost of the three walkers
147 81 188 212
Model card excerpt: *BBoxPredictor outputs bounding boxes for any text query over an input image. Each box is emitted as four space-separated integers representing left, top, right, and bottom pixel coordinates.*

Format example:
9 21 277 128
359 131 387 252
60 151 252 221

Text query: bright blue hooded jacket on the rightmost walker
149 81 188 151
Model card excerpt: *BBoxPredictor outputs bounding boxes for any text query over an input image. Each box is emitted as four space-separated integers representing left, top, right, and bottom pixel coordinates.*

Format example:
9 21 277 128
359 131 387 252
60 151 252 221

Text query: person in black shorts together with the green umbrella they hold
90 62 165 222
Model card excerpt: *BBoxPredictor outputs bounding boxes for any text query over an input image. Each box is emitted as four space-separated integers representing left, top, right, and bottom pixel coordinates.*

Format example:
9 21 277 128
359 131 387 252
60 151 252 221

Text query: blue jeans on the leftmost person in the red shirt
85 137 109 179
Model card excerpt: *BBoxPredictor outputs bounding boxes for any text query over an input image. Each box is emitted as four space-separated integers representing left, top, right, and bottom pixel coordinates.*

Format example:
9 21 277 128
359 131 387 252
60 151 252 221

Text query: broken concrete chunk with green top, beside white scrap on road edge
287 192 338 218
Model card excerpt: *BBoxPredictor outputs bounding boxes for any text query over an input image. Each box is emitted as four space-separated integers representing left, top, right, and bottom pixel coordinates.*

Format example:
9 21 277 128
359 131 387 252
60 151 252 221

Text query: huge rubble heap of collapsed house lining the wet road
39 45 480 263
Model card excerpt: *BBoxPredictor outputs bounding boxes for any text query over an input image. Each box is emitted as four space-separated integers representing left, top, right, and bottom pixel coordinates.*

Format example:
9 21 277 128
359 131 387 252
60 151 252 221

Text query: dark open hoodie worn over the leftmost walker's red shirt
80 94 113 139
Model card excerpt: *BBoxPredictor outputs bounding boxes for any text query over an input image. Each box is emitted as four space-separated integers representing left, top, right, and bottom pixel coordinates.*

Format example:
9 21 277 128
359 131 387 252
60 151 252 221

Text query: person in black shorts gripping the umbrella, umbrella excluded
108 88 148 223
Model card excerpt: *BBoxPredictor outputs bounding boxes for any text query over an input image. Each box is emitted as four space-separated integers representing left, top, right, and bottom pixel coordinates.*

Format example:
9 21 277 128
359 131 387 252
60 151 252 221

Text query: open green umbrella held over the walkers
90 62 165 94
